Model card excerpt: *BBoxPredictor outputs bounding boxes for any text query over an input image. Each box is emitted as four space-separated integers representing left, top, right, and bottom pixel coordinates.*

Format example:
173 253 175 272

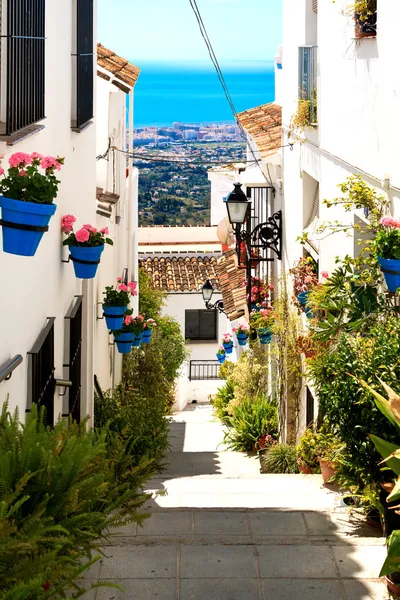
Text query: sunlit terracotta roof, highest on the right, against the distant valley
236 102 282 158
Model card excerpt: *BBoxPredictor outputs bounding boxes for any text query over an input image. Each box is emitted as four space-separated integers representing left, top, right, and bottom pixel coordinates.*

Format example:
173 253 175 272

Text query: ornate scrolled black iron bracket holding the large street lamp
235 210 282 261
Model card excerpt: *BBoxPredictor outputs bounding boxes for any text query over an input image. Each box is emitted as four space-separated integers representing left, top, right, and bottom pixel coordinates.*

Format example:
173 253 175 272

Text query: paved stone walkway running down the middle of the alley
90 405 388 600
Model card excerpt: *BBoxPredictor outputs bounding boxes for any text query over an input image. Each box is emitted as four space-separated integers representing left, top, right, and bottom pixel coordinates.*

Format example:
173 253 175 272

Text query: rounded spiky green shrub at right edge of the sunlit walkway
224 395 278 451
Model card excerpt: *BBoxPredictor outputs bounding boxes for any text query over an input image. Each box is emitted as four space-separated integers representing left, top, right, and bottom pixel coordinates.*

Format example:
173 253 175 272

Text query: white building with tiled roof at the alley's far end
139 226 237 410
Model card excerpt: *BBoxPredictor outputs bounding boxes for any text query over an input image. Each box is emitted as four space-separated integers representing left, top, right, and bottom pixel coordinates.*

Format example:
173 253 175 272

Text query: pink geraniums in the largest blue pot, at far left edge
0 152 64 256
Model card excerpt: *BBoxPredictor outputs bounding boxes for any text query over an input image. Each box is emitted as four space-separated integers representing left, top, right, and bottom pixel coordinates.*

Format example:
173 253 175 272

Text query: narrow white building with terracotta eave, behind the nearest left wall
93 44 140 390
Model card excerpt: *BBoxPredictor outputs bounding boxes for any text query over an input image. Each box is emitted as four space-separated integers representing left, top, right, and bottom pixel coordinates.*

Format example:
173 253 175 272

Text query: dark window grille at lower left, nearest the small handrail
28 317 55 425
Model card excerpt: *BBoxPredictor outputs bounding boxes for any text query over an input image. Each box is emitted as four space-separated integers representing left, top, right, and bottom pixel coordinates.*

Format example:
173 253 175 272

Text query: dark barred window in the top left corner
0 0 45 136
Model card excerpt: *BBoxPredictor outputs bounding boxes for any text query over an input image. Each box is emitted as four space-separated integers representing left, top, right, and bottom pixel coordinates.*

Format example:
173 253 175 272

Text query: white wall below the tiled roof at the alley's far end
163 292 237 411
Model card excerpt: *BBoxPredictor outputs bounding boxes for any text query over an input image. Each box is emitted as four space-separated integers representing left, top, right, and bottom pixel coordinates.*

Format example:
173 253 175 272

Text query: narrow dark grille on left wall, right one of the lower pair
64 296 82 423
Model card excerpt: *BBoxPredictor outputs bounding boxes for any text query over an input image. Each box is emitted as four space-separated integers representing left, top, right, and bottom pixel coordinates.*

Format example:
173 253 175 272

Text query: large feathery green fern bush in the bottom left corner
0 404 148 600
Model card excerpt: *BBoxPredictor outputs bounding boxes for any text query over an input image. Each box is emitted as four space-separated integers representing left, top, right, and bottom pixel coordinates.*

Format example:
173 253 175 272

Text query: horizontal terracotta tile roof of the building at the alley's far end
139 254 219 292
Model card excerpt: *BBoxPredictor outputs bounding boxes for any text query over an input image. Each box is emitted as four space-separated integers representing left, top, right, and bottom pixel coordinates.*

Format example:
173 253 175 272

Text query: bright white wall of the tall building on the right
281 0 400 429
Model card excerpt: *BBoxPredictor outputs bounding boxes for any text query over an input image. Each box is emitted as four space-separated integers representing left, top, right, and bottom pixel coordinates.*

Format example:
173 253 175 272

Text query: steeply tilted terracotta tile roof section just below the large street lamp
217 250 248 321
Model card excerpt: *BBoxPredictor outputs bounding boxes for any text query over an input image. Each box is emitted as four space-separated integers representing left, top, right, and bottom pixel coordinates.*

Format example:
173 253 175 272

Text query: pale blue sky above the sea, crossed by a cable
98 0 282 66
